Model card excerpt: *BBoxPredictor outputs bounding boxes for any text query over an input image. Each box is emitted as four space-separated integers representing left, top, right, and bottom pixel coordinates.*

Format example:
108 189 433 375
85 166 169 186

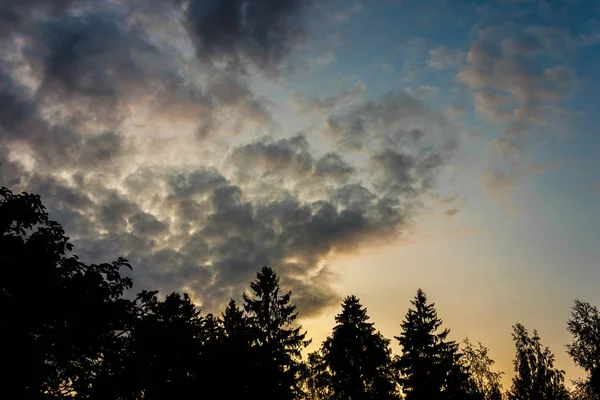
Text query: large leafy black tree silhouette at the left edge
0 187 132 399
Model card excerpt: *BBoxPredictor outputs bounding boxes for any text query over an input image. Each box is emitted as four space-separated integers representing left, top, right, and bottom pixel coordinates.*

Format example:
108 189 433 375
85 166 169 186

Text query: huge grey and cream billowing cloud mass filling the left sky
0 0 454 316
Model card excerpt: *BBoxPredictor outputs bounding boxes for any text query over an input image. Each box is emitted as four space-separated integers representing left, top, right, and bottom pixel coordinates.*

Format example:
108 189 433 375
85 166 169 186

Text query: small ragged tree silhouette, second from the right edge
508 324 569 400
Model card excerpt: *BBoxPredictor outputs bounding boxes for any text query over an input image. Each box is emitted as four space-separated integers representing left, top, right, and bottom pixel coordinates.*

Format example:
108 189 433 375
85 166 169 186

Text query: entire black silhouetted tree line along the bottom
0 187 600 400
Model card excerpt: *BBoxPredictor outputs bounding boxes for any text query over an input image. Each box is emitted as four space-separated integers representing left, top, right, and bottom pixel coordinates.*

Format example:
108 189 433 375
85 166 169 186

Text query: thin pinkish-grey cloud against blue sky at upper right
457 26 577 197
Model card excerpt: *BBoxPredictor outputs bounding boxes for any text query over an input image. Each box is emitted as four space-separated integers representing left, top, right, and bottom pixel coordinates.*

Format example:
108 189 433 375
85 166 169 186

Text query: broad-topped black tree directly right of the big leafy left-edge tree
116 291 206 399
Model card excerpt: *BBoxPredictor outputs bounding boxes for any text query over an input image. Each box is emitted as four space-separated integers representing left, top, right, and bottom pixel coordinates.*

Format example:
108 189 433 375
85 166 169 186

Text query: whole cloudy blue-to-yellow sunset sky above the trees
0 0 600 386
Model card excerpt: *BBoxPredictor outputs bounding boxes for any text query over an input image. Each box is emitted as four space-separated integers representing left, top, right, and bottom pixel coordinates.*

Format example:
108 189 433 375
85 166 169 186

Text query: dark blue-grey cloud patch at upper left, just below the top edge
32 12 156 101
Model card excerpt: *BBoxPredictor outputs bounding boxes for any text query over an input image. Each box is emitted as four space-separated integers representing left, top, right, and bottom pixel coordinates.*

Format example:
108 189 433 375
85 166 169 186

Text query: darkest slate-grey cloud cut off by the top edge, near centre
186 0 314 75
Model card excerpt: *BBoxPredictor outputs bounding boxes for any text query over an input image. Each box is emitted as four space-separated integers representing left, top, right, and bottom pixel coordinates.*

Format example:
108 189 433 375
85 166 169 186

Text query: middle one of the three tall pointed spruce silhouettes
311 296 398 400
